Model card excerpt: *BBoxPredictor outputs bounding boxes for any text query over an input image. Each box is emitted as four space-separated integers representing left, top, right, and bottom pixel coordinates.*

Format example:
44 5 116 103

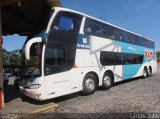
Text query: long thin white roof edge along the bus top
52 7 153 41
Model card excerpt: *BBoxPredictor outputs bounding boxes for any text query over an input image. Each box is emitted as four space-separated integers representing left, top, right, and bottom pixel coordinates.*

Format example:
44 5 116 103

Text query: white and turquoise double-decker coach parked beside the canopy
19 7 157 100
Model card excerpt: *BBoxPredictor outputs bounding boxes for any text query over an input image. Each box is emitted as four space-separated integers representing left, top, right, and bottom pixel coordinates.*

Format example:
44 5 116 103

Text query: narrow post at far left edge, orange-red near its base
0 6 4 109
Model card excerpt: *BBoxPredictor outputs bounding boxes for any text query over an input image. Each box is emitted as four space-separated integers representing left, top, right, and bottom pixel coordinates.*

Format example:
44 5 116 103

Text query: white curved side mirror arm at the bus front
24 37 43 60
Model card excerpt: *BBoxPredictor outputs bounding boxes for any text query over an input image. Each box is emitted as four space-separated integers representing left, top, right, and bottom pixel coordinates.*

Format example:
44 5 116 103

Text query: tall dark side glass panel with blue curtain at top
44 11 82 76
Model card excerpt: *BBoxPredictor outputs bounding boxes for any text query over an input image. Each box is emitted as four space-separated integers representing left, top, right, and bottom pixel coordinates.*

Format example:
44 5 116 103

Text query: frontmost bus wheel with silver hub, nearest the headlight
82 73 97 95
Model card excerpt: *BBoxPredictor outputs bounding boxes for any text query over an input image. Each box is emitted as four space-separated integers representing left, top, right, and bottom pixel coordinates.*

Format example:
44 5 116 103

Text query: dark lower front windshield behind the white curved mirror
24 43 42 77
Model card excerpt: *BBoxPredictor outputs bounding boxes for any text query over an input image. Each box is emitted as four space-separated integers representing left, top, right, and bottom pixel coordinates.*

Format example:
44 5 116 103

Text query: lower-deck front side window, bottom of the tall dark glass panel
45 43 75 75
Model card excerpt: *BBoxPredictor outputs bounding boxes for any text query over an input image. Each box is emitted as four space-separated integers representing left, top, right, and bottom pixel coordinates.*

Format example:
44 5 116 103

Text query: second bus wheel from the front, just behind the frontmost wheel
102 72 114 90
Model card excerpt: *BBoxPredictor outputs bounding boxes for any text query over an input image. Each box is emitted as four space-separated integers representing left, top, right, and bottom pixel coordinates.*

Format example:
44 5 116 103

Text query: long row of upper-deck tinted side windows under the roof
84 18 154 48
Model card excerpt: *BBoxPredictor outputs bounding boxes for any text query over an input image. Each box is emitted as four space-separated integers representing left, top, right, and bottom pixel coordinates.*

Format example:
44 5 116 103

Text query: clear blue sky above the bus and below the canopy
3 0 160 51
